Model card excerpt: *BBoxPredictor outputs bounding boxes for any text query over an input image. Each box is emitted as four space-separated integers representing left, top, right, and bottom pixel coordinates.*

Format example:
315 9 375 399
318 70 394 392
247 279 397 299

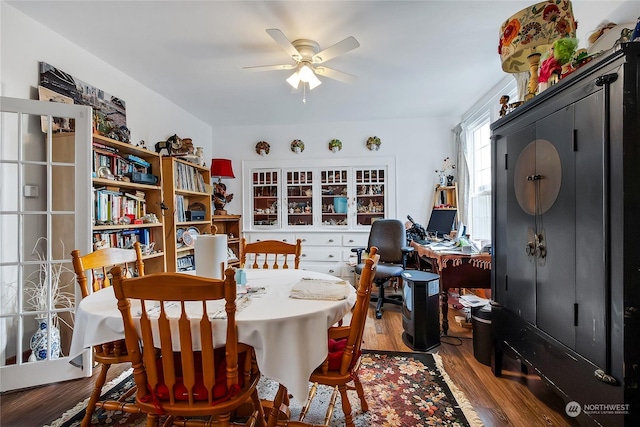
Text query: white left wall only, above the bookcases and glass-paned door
0 2 212 156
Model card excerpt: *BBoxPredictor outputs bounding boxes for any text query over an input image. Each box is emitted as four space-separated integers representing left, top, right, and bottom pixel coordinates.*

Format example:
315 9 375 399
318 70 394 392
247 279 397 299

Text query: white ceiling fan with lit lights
244 28 360 90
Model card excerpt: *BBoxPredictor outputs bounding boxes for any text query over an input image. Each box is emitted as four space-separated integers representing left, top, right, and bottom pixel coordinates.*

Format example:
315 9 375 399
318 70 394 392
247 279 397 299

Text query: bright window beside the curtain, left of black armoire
467 117 491 240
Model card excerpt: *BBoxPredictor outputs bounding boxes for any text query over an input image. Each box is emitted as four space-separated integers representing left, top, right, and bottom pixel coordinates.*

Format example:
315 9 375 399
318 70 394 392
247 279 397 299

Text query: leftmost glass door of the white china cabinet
252 170 280 227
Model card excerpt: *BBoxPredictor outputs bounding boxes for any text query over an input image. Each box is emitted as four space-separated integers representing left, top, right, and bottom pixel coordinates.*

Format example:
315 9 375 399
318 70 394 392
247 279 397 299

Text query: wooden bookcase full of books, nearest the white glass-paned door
92 134 166 273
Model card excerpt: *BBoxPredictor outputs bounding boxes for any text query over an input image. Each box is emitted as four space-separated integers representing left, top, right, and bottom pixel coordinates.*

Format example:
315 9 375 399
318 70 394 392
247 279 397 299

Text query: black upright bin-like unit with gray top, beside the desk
402 270 440 351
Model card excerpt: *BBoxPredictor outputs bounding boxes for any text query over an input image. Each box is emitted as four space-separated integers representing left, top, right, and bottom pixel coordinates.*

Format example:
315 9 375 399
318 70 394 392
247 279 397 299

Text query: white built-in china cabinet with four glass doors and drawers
243 157 396 280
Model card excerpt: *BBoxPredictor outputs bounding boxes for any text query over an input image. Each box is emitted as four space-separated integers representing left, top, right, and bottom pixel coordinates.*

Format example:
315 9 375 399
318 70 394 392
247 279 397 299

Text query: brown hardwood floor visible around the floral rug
0 305 578 427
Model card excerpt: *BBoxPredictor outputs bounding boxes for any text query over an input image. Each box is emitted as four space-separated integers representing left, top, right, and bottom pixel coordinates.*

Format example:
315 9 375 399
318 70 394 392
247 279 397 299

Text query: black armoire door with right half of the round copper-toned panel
536 106 576 348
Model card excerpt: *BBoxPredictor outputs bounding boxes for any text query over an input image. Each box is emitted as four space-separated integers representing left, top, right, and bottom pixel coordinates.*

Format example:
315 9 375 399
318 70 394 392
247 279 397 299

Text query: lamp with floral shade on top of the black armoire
498 0 577 100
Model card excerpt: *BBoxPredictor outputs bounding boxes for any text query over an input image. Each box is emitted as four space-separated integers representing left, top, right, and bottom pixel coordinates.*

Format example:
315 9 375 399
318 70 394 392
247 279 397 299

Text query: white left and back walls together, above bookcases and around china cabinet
0 2 460 224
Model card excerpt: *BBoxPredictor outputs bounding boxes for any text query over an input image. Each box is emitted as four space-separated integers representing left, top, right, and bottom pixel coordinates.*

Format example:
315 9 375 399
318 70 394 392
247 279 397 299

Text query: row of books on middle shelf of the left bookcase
92 187 147 224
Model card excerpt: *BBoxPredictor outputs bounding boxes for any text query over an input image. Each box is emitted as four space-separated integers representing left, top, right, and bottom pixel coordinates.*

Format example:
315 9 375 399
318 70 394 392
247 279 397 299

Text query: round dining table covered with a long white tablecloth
69 269 356 403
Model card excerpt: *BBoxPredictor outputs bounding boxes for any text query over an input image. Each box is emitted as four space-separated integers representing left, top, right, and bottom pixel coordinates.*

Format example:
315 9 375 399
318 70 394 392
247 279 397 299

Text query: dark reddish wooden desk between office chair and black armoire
411 242 491 335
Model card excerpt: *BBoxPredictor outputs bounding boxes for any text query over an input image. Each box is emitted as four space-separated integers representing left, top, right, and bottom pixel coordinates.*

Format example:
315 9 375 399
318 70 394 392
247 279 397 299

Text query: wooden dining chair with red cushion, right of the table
300 246 380 427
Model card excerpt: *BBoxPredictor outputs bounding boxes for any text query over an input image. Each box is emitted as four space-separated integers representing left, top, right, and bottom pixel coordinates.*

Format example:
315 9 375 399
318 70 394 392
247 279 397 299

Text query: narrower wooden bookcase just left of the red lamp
162 157 212 272
